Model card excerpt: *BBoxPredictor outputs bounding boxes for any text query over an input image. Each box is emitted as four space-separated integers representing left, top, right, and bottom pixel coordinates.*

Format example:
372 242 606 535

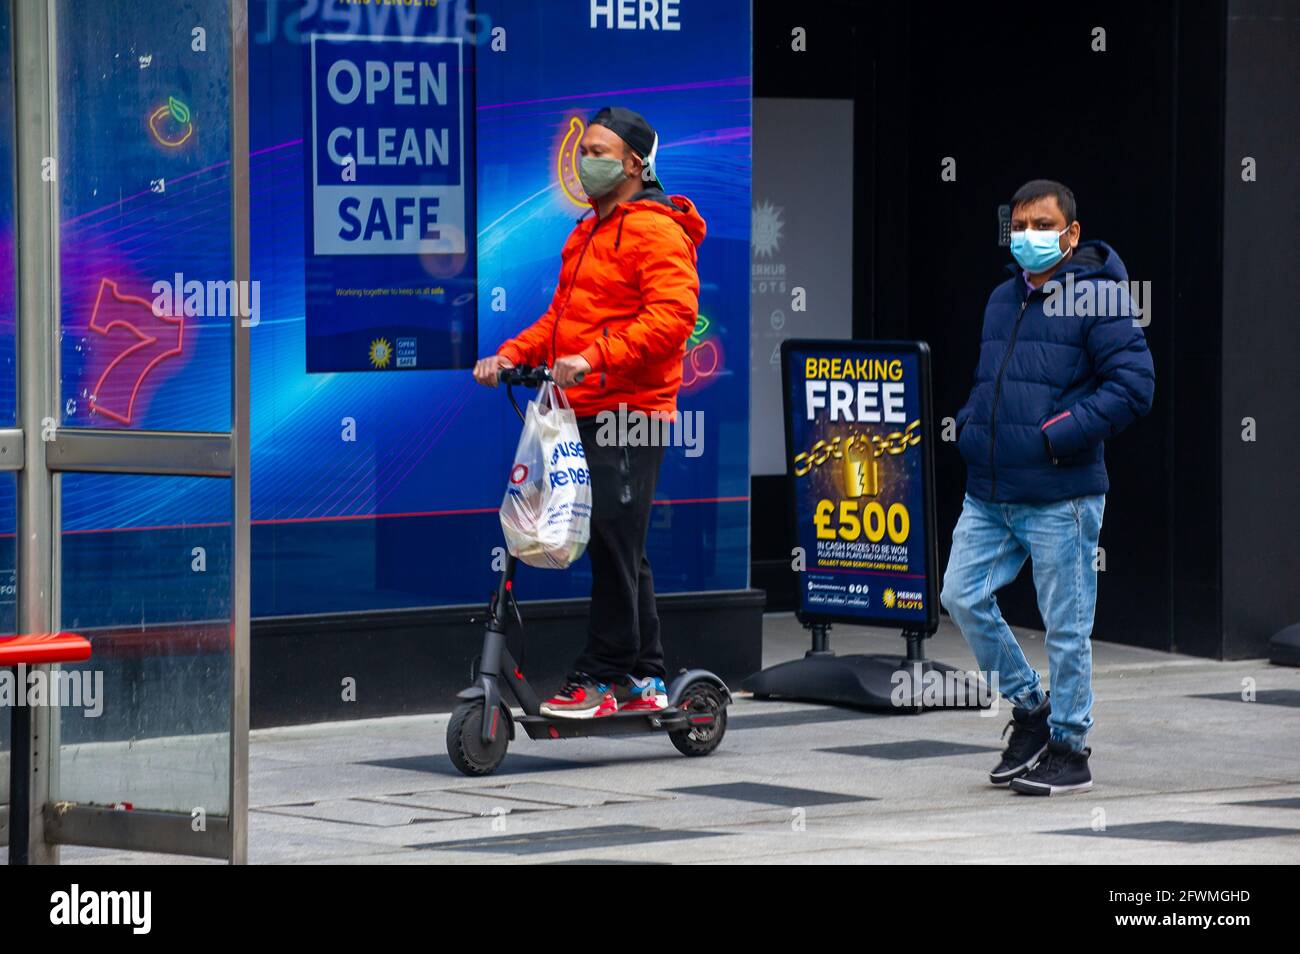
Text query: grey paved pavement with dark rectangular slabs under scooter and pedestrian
55 615 1300 864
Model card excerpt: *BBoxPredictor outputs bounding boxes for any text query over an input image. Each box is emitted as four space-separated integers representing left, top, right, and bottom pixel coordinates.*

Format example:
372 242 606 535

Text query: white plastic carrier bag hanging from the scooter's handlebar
501 381 592 569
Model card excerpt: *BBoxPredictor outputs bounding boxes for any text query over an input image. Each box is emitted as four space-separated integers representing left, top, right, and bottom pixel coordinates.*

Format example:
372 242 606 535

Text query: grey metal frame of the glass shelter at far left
0 0 251 864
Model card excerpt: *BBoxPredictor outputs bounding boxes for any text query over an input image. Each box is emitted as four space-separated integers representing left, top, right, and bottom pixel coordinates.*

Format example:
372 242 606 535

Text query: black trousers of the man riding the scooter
573 417 667 681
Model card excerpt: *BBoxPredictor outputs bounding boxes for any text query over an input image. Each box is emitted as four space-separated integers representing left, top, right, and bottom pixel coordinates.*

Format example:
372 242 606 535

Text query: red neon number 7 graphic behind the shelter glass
90 278 185 425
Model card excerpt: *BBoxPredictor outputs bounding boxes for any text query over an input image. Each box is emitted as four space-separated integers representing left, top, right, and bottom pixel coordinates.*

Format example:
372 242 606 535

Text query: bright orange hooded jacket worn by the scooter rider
497 188 705 417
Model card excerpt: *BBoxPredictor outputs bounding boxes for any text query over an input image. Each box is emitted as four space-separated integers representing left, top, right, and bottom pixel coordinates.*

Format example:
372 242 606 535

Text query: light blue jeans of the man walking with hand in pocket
940 494 1106 751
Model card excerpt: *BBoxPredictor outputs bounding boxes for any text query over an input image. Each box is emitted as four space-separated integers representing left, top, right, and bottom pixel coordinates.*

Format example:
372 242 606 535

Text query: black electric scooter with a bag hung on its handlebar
447 365 732 776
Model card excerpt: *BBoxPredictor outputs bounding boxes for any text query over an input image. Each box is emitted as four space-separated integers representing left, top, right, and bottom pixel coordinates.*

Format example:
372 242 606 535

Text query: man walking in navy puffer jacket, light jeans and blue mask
941 179 1156 795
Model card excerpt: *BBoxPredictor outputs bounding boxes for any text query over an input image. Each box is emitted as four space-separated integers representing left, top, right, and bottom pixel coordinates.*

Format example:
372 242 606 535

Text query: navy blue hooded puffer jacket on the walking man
957 242 1156 503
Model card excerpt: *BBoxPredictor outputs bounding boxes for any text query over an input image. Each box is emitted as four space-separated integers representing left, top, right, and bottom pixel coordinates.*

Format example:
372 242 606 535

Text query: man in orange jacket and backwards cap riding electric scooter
475 107 705 719
